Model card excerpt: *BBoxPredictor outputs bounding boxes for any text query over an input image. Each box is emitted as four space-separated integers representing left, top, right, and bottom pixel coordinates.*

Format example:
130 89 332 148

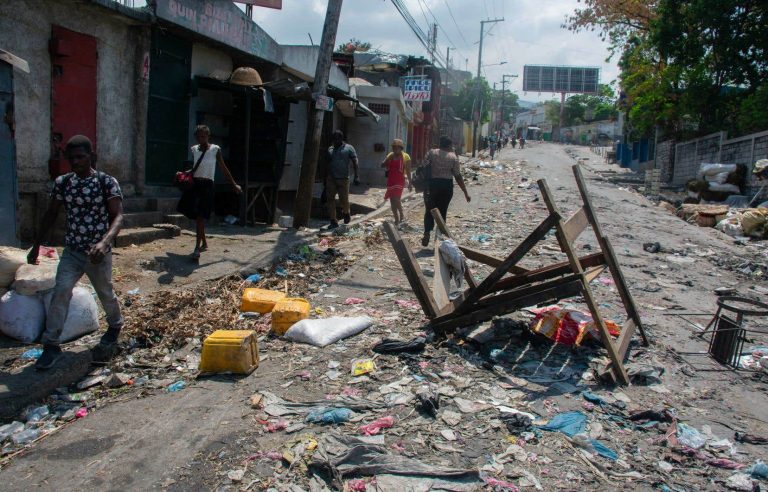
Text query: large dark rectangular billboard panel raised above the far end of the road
523 65 600 94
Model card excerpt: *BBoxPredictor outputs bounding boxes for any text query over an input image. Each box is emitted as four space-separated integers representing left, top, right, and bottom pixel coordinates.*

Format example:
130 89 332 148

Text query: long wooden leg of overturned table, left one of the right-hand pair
538 179 629 385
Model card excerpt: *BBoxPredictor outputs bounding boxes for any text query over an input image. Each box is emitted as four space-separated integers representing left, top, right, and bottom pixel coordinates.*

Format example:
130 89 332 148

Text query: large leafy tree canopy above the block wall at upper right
565 0 768 137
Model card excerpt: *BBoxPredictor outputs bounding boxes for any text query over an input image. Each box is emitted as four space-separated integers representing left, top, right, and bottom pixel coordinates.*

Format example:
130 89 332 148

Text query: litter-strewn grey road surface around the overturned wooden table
0 143 768 490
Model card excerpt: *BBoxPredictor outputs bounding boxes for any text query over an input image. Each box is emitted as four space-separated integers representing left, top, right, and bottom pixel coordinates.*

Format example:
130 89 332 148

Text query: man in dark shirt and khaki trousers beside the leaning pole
325 130 360 229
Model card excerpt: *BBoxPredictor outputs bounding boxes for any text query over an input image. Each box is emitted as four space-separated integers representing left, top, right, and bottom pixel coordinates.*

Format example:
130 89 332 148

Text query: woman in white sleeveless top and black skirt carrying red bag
179 125 243 259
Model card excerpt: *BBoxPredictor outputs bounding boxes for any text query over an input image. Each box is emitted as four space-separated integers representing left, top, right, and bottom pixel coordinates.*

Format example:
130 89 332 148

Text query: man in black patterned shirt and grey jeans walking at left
27 135 123 370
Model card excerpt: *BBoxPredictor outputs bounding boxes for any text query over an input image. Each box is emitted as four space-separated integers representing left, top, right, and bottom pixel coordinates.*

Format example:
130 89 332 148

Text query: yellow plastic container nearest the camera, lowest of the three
199 330 259 374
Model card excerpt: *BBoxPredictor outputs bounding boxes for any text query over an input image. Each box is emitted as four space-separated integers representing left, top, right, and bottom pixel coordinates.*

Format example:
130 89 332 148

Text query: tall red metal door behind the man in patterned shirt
48 26 96 177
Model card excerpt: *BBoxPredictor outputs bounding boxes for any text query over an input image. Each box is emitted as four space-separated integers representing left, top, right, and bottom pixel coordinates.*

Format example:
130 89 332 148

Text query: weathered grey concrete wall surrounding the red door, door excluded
0 0 149 239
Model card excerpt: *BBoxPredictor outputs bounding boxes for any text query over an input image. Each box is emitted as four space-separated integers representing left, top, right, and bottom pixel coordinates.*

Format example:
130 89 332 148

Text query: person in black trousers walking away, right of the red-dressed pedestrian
421 137 472 247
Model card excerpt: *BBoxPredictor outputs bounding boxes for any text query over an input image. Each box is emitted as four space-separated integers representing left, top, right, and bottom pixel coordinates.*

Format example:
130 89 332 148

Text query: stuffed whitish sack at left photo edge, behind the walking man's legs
0 291 45 343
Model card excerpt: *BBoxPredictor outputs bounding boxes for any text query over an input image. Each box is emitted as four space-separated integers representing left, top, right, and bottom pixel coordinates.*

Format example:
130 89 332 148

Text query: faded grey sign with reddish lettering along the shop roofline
155 0 281 64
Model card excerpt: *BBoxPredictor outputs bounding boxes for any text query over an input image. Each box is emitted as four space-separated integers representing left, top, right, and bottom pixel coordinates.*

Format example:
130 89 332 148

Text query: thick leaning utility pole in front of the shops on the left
293 0 343 229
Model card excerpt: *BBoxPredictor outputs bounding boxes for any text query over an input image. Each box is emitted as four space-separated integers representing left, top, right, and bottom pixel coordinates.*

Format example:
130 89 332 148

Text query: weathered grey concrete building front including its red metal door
0 0 151 240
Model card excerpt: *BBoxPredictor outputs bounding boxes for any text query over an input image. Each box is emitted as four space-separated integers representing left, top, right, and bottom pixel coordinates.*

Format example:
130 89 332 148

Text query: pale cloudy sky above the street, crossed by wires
254 0 618 101
